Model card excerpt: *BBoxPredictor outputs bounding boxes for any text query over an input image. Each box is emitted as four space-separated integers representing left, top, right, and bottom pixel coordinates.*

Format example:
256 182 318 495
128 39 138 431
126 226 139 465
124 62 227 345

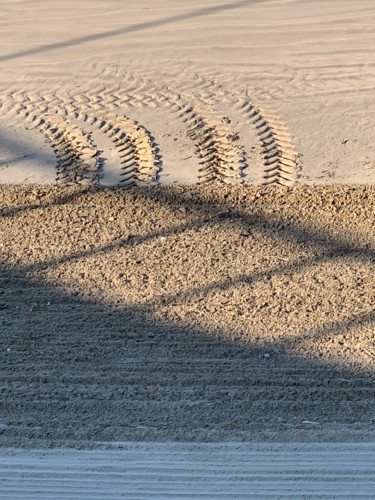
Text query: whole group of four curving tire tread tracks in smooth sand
0 70 300 186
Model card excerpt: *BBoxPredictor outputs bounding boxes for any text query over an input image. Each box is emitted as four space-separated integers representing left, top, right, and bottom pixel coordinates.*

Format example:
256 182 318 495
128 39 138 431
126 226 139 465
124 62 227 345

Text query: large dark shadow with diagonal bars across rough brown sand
0 183 375 446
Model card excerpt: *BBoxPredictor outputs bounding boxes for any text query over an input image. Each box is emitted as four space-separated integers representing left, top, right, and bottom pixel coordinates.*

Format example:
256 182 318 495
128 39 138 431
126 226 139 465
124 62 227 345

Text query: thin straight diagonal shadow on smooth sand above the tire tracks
0 0 266 62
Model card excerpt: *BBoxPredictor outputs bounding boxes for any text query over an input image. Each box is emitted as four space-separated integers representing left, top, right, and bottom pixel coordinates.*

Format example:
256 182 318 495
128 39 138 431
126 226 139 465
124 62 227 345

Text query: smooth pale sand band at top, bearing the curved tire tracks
0 0 375 185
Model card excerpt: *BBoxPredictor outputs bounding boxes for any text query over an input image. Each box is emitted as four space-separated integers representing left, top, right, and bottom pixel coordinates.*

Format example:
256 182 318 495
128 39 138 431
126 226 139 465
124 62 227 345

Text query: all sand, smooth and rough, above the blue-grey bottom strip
0 0 375 454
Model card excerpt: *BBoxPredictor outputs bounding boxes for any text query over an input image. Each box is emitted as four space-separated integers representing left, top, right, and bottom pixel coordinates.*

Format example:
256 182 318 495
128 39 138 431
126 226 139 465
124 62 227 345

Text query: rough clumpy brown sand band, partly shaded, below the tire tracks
0 183 375 446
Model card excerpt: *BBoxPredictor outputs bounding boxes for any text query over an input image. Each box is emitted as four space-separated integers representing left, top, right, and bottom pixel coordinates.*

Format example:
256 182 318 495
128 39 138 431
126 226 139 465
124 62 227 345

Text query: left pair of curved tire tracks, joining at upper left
0 94 160 185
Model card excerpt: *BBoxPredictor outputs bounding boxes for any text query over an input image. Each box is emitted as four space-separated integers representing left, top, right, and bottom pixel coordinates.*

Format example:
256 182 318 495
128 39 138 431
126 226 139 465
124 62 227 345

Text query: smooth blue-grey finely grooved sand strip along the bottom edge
0 443 375 500
